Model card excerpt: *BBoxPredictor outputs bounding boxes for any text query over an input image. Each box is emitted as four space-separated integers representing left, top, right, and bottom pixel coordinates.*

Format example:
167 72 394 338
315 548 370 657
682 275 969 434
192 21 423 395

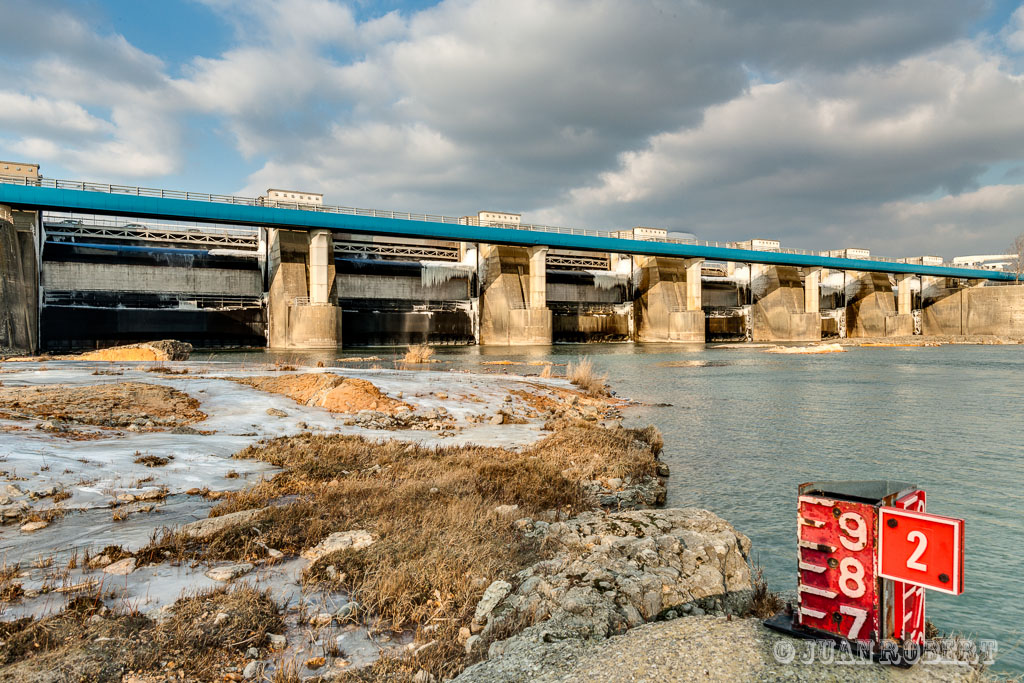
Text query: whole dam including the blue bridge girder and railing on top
0 173 1024 351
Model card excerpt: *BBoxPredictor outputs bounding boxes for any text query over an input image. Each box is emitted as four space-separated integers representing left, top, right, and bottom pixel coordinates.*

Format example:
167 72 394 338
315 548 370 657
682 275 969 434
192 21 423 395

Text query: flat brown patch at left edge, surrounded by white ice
0 382 206 429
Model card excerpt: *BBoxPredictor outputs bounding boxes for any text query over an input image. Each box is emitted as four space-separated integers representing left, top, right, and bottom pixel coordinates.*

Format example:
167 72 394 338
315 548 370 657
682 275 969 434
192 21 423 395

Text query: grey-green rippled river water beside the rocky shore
209 344 1024 674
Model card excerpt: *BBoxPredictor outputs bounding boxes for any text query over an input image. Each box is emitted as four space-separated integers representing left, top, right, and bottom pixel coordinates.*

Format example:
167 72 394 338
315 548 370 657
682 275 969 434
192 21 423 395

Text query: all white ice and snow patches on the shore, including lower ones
0 361 585 666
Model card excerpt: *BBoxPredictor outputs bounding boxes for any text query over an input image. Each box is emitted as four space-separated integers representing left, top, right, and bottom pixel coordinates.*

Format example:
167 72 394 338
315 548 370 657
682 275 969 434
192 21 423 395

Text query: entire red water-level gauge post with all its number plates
765 481 964 663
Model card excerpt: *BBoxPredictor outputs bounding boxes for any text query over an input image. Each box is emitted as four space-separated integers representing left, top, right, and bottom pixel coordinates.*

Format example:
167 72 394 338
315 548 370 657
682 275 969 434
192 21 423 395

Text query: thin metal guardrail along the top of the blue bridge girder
0 175 987 269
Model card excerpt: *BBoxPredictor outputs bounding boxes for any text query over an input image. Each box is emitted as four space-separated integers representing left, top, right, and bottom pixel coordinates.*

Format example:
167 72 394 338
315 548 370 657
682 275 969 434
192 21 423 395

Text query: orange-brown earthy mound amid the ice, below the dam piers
234 373 412 415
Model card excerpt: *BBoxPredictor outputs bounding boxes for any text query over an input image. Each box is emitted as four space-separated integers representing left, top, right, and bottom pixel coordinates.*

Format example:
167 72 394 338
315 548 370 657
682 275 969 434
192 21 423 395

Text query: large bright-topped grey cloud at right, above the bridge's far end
547 43 1024 255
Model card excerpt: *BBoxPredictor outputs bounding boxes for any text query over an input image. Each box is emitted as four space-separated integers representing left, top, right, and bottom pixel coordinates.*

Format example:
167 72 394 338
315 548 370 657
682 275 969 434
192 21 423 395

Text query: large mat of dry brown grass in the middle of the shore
140 421 659 679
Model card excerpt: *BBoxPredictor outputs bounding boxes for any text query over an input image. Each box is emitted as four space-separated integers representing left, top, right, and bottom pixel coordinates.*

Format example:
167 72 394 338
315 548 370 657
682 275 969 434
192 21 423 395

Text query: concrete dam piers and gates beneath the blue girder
0 209 1024 351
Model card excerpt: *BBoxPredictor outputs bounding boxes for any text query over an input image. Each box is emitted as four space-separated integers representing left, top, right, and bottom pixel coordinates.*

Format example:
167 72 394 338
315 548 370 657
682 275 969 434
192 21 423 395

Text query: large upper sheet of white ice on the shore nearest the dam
0 361 564 516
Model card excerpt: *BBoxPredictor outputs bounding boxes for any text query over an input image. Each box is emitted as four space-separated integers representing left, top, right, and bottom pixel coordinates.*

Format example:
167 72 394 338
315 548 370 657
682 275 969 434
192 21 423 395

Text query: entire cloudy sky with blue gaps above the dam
0 0 1024 257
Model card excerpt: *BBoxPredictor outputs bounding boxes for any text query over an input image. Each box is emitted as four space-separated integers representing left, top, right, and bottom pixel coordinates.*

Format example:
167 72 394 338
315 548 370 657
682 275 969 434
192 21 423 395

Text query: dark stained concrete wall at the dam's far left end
0 206 39 353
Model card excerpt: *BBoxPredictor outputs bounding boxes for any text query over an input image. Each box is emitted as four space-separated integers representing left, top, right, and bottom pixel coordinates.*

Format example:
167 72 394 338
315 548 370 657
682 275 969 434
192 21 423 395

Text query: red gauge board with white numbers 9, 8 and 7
798 496 879 640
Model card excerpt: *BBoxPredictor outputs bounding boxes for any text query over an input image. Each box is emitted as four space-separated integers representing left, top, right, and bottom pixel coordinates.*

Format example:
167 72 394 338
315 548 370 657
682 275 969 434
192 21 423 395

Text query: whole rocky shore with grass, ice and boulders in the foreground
0 350 991 683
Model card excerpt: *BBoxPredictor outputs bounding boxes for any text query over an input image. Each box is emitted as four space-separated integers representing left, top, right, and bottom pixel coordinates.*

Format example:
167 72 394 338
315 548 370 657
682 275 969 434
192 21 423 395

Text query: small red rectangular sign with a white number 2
879 507 964 595
